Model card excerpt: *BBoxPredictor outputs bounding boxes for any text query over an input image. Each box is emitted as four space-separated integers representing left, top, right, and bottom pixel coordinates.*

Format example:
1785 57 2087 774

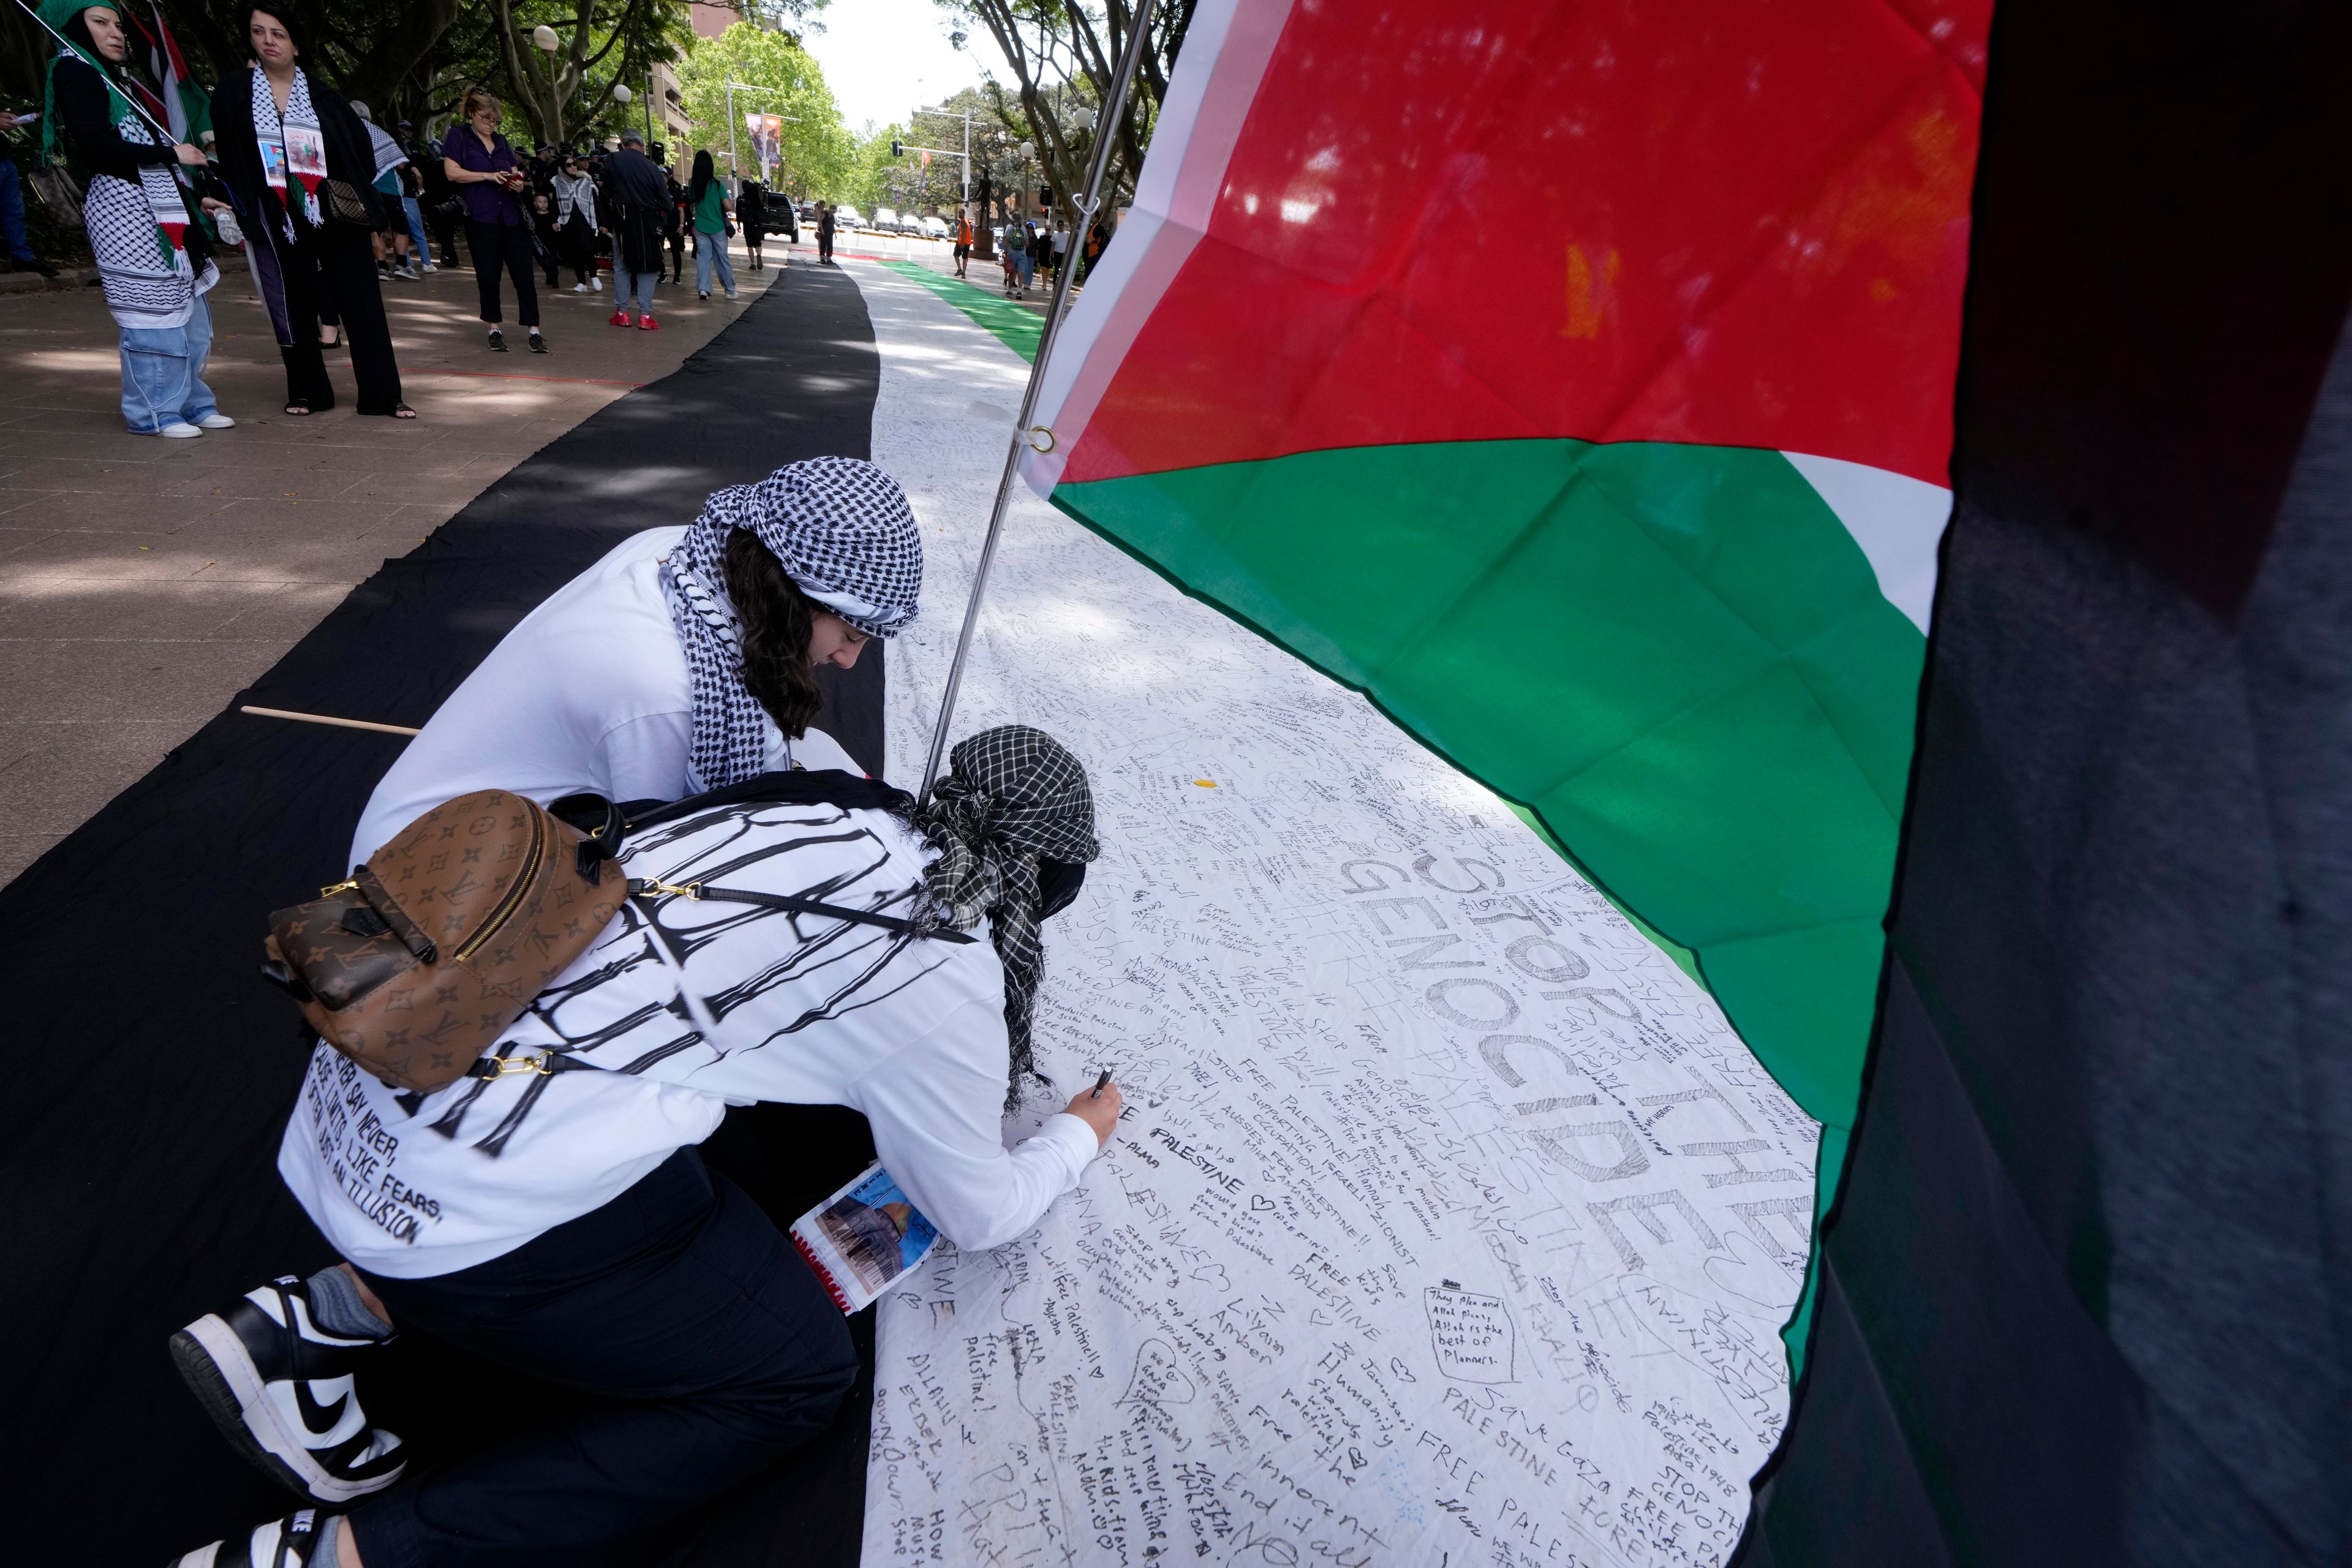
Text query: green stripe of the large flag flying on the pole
1054 440 1926 1363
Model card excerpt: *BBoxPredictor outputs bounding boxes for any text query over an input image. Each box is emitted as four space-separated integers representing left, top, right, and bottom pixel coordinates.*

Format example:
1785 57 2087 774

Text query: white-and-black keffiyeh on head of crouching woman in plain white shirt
661 458 922 790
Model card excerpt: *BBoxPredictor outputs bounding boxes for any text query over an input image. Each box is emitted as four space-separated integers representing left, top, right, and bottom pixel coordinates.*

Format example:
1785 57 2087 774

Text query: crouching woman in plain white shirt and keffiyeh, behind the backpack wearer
353 458 922 863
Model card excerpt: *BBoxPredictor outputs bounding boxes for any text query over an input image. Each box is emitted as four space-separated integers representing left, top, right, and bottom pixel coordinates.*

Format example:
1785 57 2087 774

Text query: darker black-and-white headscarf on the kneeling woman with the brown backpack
915 724 1101 1114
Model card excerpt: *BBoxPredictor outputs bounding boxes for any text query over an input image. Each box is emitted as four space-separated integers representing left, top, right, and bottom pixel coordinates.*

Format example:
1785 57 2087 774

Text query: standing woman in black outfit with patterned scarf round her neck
212 5 417 418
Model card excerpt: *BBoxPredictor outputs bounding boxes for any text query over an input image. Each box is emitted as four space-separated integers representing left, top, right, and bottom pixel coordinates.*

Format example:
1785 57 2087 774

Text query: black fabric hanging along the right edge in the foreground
1736 0 2352 1568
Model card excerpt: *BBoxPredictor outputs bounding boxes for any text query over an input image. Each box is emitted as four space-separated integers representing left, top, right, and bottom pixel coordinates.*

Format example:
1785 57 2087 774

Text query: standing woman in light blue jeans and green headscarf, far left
40 0 238 440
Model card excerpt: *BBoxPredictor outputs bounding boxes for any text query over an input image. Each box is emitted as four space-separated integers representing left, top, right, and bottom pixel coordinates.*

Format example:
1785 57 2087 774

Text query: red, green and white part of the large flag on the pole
1025 0 1990 1352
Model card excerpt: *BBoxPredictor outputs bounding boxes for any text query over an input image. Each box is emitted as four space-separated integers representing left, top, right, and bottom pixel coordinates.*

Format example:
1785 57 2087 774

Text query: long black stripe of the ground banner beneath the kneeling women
0 268 882 1566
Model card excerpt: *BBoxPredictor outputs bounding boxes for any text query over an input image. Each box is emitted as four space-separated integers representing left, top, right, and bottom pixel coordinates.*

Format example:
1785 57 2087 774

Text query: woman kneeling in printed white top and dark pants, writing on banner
172 726 1120 1568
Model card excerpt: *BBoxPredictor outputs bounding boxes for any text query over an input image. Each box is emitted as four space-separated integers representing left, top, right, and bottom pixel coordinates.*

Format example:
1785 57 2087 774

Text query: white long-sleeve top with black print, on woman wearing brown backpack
277 804 1098 1279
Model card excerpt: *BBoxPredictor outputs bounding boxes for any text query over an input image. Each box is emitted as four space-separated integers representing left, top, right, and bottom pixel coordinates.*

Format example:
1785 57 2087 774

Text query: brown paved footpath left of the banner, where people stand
0 242 790 884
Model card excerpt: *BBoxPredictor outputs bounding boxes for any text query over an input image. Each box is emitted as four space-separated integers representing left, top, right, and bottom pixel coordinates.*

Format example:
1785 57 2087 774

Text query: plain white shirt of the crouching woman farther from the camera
350 529 863 865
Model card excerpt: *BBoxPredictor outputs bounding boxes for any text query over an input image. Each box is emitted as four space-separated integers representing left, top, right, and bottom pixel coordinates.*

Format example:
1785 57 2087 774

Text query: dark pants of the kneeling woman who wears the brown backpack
350 1150 859 1568
